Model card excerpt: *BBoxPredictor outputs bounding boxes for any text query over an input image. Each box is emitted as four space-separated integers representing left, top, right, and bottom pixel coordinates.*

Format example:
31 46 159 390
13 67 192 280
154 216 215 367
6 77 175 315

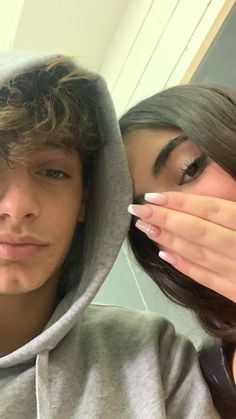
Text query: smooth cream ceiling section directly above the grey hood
12 0 129 70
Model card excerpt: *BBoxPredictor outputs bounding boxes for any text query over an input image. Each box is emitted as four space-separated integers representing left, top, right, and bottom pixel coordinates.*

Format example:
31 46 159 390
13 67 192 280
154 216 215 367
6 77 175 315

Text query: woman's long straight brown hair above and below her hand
120 85 236 343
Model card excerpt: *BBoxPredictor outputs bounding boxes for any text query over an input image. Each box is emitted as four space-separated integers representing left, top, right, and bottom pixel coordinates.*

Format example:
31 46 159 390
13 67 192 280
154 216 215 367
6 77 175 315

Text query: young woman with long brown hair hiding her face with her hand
120 85 236 418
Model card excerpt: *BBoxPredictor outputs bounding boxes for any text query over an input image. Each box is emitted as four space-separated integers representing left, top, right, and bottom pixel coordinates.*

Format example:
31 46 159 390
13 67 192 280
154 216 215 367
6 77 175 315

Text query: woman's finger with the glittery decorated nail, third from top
141 223 236 286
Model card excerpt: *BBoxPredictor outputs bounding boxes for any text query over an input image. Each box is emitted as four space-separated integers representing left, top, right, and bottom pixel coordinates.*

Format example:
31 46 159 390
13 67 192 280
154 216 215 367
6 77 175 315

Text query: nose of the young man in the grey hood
0 174 40 223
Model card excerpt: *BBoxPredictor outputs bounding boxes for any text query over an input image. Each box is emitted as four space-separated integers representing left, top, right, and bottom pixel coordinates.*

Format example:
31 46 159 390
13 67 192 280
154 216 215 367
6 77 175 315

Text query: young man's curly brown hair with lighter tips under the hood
0 57 100 184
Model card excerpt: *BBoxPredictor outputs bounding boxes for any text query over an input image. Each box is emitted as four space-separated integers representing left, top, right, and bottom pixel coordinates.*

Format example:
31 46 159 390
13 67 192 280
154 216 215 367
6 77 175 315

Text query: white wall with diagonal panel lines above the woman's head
101 0 225 115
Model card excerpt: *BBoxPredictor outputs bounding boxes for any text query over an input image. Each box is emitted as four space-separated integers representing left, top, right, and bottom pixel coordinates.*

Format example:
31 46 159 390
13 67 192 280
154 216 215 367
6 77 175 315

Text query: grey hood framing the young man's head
0 51 132 368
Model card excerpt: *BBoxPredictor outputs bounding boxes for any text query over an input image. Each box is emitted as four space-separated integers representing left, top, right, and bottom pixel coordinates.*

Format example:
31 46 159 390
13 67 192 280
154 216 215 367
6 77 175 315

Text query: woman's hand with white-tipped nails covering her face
129 192 236 303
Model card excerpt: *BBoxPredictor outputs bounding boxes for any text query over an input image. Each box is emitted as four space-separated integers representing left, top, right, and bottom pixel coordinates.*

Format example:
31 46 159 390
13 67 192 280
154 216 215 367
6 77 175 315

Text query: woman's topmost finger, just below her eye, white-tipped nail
145 192 236 230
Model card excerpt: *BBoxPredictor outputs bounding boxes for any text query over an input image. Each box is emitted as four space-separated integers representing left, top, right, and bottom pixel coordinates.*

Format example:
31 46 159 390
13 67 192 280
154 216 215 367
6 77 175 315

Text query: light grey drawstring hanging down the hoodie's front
35 351 50 419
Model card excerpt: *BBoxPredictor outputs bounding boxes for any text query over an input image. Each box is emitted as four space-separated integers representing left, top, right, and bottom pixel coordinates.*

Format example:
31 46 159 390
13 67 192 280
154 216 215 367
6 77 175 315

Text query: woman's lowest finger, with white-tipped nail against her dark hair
159 252 236 303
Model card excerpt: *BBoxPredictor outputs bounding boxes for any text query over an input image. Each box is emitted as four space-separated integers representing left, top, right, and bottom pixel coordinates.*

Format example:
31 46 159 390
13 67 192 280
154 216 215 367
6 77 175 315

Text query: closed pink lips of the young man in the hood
0 234 49 261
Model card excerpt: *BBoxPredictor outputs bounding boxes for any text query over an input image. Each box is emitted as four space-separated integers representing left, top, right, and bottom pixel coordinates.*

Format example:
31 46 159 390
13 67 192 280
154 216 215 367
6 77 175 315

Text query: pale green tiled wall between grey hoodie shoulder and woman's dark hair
94 245 207 348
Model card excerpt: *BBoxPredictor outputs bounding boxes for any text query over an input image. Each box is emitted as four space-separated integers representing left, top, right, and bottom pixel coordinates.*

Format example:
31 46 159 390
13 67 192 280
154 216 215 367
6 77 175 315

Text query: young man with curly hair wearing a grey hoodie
0 53 218 419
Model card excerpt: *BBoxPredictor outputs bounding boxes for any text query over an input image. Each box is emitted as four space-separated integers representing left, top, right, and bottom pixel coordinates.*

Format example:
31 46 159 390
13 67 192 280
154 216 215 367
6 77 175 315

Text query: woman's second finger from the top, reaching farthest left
130 204 236 260
